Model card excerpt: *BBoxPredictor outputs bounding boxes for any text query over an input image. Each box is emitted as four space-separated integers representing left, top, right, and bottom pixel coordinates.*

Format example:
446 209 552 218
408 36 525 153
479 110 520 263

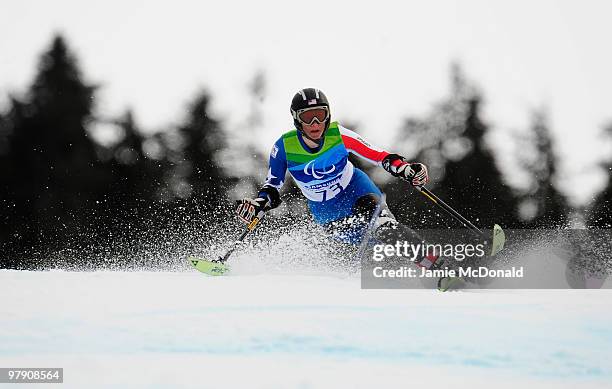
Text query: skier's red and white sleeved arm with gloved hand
339 126 429 186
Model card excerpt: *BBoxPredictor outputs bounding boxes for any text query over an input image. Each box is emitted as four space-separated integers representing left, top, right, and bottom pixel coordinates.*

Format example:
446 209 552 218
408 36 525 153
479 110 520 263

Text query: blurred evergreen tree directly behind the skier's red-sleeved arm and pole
385 65 519 228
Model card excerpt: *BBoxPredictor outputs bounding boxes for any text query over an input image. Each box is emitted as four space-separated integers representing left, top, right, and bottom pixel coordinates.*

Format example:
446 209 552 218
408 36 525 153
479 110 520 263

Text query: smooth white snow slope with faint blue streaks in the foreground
0 270 612 388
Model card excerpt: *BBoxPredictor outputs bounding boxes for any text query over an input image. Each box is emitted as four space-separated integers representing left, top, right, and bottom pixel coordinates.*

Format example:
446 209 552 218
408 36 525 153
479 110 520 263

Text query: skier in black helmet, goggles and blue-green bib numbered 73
237 88 435 267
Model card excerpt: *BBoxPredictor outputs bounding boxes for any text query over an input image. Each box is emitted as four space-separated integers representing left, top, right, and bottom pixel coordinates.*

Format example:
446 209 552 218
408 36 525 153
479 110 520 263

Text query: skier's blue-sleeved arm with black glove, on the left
236 139 287 224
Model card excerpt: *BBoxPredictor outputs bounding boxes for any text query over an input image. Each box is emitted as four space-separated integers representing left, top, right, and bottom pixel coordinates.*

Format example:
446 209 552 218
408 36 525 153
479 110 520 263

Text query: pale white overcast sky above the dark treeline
0 0 612 205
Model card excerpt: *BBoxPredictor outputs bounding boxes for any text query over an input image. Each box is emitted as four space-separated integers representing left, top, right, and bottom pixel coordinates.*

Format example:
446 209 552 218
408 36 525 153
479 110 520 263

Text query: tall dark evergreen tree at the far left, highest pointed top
4 36 104 266
